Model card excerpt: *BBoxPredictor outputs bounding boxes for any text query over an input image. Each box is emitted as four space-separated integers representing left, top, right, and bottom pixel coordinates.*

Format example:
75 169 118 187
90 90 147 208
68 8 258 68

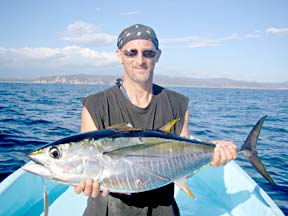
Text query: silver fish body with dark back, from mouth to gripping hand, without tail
23 129 215 193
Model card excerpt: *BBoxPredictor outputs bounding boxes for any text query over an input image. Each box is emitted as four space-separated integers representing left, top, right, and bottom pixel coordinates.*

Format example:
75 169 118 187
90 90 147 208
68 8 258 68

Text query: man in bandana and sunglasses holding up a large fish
75 24 236 215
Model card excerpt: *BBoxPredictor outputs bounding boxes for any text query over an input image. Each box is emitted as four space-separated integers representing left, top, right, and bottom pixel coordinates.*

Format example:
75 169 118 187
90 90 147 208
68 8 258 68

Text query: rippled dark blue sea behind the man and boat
0 83 288 215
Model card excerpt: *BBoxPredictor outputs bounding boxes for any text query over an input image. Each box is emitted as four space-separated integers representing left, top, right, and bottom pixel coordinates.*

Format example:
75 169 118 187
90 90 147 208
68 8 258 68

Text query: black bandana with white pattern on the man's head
117 24 159 49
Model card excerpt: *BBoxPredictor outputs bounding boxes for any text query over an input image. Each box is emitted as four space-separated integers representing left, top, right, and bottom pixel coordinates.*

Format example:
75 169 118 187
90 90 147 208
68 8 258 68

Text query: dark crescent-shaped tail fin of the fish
240 116 276 185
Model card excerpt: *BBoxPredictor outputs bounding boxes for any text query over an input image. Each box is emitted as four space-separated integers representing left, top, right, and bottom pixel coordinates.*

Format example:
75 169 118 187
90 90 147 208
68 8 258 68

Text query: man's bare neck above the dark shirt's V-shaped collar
123 80 153 108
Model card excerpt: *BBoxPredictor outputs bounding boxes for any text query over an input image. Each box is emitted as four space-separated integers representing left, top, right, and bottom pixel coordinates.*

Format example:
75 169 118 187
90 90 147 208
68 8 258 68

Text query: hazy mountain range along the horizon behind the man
0 74 288 90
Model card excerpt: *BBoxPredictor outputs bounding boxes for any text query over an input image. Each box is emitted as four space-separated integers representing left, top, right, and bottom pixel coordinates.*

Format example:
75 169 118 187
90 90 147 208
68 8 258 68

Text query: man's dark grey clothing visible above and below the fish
82 84 189 215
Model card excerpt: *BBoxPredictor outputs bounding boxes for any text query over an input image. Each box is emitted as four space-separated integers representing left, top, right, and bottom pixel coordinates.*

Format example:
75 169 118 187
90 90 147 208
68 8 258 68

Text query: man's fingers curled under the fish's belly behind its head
74 179 109 198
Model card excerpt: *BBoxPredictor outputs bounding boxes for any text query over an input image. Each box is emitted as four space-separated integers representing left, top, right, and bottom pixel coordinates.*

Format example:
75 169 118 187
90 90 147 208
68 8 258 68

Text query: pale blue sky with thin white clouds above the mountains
0 0 288 82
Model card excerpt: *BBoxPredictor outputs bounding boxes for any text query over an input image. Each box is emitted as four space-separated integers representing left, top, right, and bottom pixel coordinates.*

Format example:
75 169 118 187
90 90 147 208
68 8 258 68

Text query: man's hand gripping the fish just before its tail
211 140 237 167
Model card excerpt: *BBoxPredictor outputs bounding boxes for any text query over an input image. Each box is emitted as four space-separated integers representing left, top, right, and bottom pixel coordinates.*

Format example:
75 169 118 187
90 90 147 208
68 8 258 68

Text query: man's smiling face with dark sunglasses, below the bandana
117 39 161 84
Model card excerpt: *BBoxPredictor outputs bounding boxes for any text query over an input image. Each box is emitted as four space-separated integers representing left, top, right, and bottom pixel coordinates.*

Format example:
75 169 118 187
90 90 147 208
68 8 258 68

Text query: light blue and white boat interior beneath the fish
0 161 284 216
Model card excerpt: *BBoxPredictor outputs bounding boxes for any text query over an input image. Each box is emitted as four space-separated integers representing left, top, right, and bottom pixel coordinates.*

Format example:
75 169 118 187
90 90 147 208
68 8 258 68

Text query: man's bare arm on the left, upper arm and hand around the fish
74 107 109 198
